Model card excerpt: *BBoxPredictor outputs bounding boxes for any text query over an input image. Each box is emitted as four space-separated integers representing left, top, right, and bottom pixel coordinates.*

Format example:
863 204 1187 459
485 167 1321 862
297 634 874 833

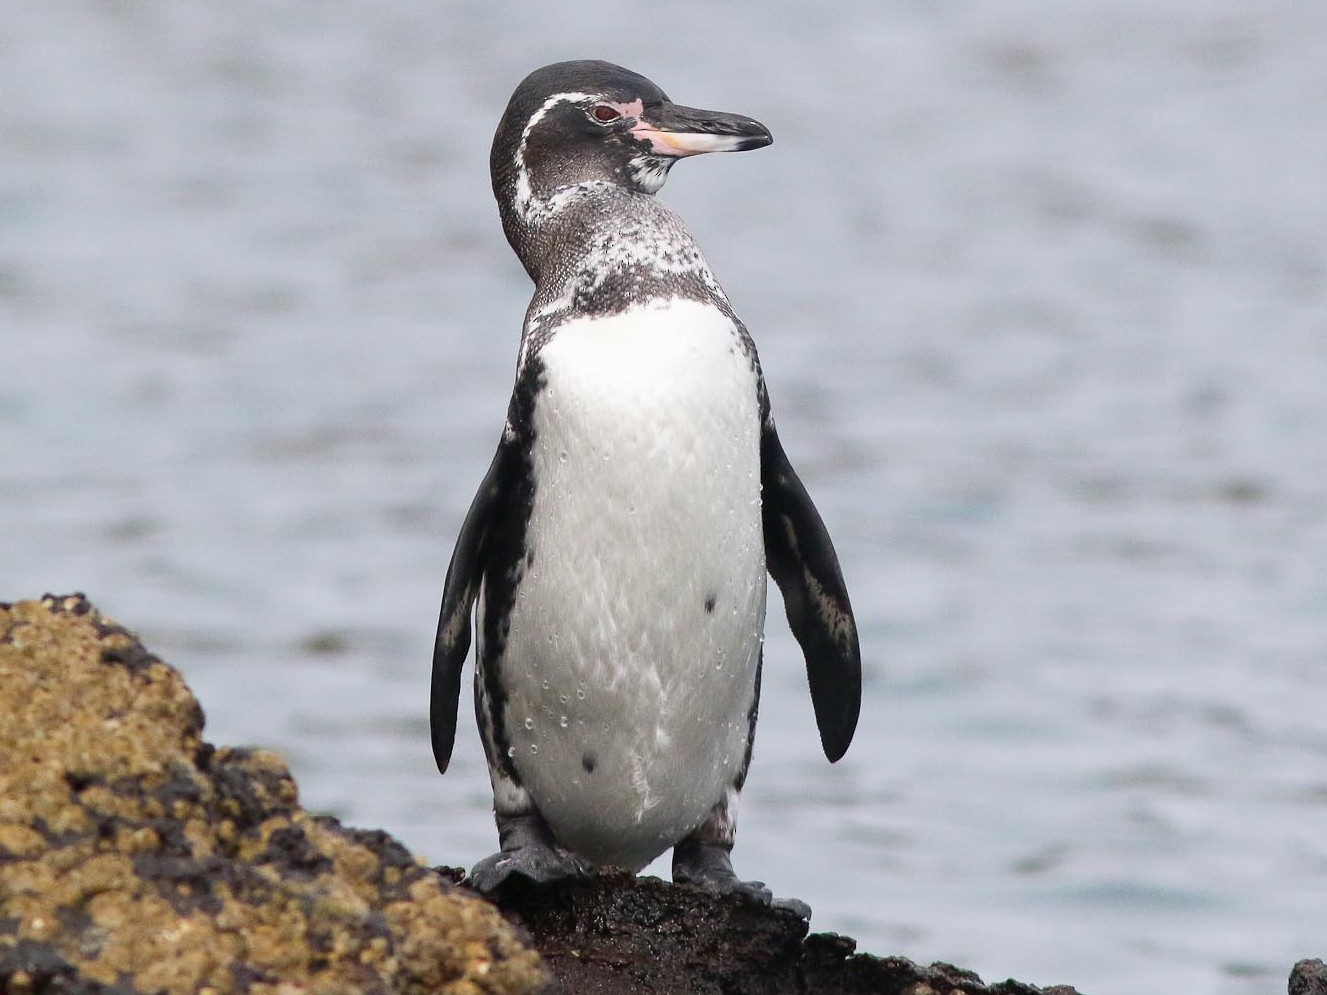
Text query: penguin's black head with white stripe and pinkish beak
490 60 774 227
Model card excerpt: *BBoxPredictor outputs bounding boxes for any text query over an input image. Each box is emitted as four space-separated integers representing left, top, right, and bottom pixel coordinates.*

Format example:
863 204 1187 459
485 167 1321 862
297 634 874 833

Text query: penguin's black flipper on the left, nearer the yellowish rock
429 431 519 773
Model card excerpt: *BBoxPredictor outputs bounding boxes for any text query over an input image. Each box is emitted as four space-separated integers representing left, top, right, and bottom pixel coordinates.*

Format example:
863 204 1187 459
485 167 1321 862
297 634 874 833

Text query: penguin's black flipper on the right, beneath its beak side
760 415 861 763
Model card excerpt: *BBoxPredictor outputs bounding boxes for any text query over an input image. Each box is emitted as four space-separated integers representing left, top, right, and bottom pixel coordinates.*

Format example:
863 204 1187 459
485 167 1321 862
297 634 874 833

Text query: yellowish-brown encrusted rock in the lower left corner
0 596 547 995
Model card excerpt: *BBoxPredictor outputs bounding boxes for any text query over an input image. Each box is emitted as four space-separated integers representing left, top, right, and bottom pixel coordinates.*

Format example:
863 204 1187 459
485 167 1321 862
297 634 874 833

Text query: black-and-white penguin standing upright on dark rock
430 61 861 914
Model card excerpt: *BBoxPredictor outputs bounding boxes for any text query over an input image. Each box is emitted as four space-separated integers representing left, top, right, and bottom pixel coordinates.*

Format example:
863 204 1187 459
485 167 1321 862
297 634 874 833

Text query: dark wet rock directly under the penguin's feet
472 873 1076 995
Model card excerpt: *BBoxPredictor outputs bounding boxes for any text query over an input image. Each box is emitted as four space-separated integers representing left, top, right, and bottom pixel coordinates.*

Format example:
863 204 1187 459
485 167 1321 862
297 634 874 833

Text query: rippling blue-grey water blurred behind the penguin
0 0 1327 995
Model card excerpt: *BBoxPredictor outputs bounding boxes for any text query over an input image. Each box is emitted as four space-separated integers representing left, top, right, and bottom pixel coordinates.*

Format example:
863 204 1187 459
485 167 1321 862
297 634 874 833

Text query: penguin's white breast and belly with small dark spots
502 300 766 870
